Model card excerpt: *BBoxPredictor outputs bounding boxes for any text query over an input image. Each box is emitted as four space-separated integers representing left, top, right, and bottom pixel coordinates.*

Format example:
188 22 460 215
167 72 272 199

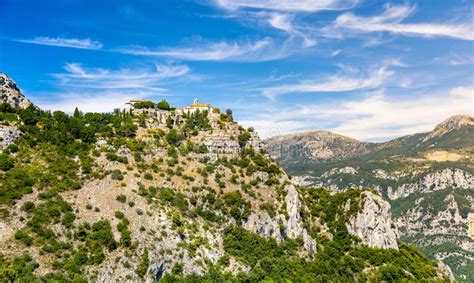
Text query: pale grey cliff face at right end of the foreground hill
346 192 398 250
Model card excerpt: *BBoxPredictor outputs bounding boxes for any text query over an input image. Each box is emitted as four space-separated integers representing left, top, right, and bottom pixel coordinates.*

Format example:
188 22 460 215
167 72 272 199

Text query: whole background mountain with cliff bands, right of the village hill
264 115 474 281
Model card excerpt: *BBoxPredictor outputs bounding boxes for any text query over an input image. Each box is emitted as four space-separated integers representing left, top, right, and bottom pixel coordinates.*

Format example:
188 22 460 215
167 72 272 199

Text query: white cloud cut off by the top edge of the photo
213 0 358 12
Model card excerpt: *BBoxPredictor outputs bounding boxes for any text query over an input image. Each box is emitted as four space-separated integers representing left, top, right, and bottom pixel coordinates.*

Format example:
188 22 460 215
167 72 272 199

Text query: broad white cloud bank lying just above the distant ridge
247 86 474 141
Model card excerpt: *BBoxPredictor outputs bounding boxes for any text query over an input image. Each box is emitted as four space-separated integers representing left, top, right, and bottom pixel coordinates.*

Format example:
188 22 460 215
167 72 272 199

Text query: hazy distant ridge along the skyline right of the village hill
265 115 474 166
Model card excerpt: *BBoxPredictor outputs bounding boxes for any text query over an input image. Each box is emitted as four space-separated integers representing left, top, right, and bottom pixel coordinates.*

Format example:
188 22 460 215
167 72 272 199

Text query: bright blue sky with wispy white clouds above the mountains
0 0 474 141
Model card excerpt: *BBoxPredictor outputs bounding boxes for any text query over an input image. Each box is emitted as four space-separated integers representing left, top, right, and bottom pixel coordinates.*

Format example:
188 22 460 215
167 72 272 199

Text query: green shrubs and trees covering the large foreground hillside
0 101 452 282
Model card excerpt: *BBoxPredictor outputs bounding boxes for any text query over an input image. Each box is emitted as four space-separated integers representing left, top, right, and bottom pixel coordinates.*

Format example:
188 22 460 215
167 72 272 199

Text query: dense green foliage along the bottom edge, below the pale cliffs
163 229 444 282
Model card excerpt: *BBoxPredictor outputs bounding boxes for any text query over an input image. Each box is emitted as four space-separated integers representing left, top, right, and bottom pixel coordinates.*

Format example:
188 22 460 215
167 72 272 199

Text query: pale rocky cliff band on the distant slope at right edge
387 168 474 200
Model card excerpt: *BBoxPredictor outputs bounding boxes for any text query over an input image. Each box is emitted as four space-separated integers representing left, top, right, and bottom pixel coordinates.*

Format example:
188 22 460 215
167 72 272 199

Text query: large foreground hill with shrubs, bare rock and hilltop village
0 74 450 282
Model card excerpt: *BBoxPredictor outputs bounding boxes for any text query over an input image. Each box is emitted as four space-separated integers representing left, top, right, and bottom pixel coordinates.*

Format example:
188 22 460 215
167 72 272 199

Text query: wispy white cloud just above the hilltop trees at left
35 63 190 112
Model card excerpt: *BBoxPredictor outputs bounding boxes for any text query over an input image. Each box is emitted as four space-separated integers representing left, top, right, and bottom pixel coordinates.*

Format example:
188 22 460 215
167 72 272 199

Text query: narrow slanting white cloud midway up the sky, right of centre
261 66 393 99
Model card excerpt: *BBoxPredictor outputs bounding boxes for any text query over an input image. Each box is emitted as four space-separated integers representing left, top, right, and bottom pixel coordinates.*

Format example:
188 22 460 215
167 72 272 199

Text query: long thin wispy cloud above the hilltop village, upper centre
119 37 288 62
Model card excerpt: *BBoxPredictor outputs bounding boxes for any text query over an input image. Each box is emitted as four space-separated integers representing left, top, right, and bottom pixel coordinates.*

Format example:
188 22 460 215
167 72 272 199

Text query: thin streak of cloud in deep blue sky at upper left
16 36 103 49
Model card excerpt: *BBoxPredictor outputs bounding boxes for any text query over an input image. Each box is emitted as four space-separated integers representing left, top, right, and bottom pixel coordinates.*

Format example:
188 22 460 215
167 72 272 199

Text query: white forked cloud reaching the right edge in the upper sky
322 4 474 40
